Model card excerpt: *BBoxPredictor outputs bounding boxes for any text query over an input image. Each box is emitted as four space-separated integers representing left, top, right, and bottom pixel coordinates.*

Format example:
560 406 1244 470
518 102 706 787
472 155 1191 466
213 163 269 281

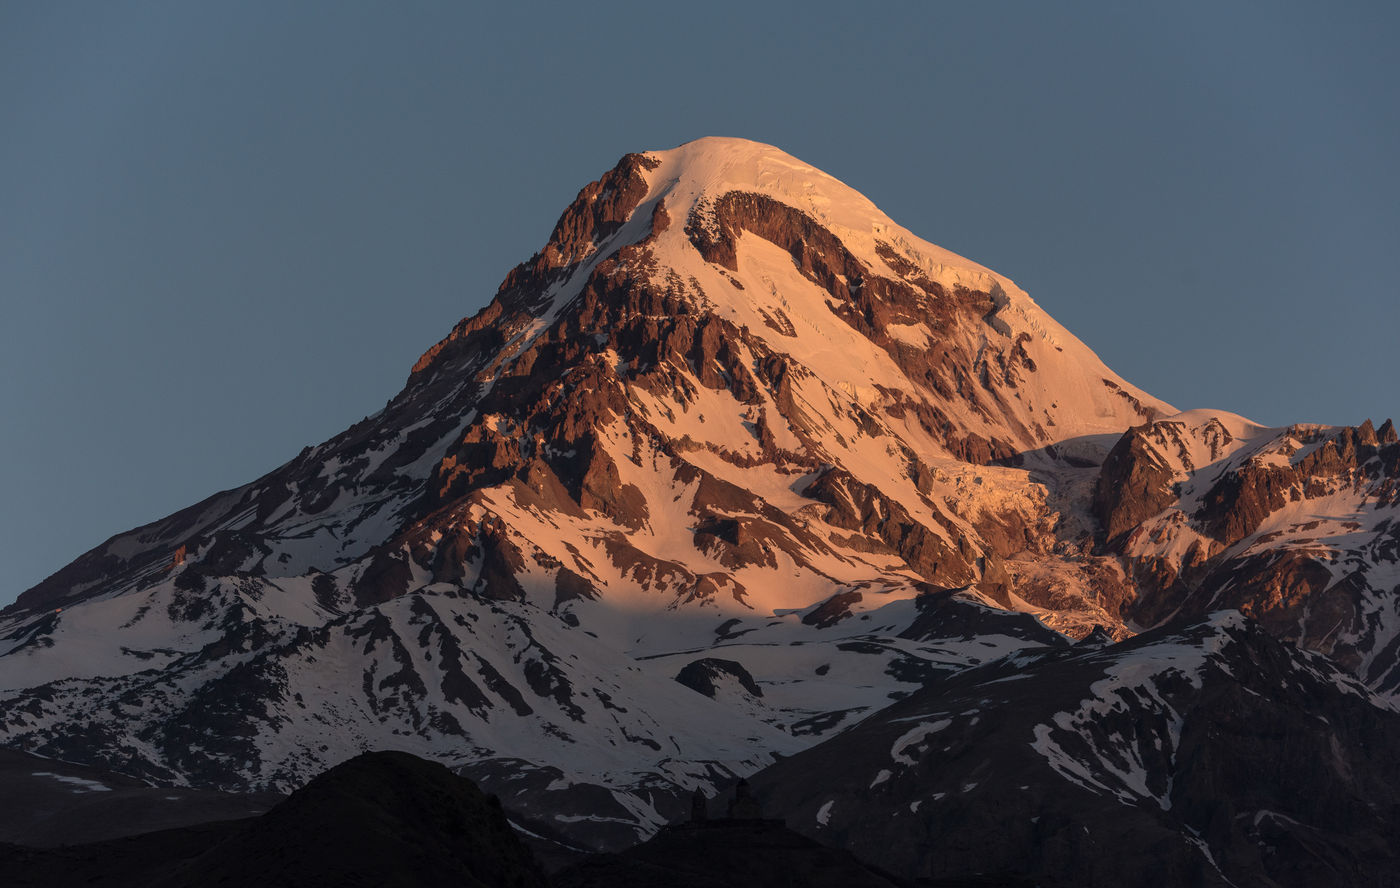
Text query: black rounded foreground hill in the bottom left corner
0 752 547 888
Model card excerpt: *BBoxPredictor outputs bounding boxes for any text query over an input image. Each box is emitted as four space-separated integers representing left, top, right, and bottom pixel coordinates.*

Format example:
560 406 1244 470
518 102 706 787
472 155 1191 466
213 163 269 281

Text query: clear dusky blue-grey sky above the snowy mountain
0 0 1400 605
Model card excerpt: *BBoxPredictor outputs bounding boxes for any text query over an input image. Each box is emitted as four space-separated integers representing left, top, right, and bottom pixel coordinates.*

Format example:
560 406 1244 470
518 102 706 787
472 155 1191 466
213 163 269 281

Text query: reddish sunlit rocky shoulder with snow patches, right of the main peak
1093 412 1400 696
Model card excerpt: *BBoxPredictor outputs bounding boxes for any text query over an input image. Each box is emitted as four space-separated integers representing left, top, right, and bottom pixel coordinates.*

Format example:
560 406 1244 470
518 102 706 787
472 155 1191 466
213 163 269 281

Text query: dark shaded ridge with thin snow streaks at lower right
752 611 1400 888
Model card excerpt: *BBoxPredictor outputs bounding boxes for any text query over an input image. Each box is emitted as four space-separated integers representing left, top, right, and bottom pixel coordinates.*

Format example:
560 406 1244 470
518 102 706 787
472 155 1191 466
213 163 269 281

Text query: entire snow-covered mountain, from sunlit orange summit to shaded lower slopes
0 139 1400 862
